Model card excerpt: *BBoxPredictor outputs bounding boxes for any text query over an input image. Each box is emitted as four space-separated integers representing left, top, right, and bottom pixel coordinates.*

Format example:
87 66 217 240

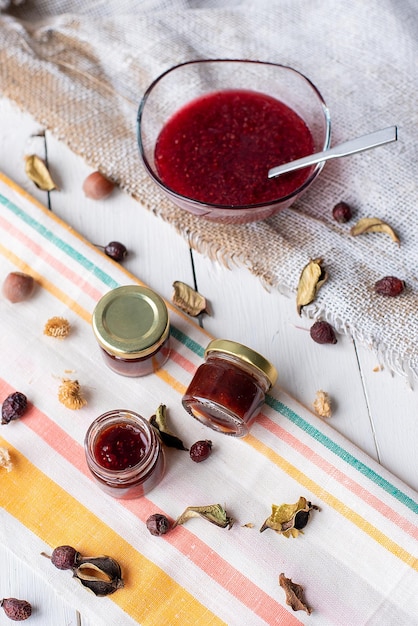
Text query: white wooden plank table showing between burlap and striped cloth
0 97 418 626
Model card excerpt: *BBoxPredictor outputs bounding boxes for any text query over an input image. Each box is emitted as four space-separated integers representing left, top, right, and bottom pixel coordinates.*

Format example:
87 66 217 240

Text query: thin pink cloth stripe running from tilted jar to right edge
258 414 418 540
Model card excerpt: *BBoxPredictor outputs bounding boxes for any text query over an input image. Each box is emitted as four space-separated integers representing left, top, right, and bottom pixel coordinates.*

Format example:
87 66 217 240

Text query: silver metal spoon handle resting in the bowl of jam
268 126 398 178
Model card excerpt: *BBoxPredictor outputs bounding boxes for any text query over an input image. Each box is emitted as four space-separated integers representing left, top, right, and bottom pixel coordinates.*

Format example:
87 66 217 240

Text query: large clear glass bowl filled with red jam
137 59 331 224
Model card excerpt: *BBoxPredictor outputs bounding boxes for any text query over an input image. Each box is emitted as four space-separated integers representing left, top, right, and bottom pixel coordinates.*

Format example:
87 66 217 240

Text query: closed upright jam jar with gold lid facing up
92 285 170 376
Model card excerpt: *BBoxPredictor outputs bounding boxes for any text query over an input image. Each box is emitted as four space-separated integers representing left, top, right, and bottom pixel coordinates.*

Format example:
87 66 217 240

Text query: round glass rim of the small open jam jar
84 409 163 485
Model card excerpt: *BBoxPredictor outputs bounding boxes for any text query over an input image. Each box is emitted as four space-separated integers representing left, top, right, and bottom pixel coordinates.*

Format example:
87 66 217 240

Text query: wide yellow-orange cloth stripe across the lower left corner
0 437 224 626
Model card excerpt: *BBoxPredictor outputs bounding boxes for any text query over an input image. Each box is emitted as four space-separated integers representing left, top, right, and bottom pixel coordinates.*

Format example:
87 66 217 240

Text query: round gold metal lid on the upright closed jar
92 285 170 359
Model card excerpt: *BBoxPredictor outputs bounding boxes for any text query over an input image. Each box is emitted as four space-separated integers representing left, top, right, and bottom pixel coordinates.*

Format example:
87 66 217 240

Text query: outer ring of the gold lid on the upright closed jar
92 285 170 360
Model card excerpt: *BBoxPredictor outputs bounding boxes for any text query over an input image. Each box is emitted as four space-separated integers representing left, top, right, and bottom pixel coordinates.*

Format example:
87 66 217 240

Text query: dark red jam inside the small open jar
94 424 147 470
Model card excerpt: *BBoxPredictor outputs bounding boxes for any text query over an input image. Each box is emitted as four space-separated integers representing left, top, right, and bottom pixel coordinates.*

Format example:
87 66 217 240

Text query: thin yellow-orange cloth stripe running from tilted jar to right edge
244 435 418 571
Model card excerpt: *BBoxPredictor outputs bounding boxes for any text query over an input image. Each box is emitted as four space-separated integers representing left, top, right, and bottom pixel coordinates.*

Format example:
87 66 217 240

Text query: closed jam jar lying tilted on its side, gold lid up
182 339 277 437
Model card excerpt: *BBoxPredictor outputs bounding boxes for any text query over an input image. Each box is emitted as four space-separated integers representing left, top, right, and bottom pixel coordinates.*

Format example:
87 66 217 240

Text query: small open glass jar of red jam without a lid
84 409 165 500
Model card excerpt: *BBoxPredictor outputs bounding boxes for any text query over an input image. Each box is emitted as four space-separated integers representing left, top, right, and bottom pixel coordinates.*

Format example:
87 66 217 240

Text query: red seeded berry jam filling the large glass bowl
155 90 314 206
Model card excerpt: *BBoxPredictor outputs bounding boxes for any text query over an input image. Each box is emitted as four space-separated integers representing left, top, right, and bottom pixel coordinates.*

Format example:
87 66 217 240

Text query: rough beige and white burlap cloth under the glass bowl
0 0 418 381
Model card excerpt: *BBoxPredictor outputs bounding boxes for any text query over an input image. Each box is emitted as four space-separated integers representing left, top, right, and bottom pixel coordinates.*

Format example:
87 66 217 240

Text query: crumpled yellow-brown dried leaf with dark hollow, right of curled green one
260 496 320 537
